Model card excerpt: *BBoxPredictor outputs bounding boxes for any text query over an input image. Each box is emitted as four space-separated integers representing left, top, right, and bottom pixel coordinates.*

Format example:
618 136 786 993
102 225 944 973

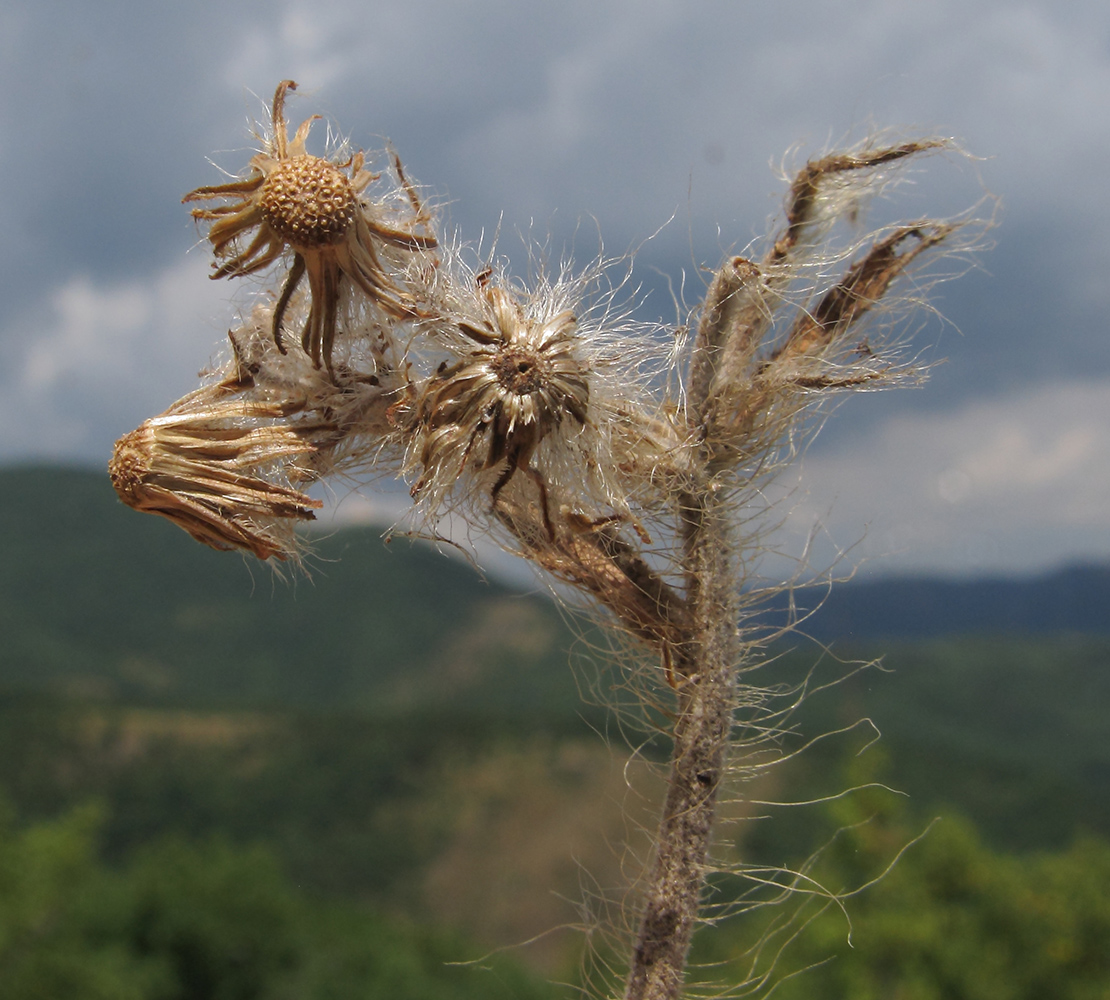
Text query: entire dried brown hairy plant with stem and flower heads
111 81 969 1000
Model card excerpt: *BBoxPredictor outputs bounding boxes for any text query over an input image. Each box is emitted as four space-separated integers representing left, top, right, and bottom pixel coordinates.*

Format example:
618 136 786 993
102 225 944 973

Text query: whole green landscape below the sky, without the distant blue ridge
0 468 1110 1000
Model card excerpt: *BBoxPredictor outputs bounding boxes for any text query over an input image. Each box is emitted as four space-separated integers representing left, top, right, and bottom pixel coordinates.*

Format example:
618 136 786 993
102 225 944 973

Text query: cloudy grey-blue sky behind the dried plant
0 0 1110 576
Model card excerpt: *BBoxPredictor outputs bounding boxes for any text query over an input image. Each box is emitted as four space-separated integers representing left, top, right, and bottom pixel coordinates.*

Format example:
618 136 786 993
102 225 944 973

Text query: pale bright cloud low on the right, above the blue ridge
784 380 1110 573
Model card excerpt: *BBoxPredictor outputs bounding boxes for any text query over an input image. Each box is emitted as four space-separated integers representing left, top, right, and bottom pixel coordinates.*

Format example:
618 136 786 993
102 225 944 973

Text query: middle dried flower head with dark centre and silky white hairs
405 240 674 517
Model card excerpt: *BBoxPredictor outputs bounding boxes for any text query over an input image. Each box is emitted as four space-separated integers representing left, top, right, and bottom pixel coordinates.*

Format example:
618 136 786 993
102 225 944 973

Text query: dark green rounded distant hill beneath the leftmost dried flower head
0 467 578 715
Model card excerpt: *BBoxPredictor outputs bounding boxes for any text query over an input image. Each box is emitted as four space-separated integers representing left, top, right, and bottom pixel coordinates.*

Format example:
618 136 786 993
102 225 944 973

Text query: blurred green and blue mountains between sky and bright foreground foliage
0 467 1110 918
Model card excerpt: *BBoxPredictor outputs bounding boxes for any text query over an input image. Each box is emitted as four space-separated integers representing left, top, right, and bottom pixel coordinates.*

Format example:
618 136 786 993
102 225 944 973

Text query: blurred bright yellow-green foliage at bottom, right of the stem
699 789 1110 1000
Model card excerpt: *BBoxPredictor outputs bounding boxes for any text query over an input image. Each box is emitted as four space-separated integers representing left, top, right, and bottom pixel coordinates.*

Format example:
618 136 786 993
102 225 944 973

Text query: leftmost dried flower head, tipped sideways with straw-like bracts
109 295 405 562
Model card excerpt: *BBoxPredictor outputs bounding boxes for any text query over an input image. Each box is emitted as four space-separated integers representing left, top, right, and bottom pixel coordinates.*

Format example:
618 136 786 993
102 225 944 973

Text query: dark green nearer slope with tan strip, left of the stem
0 694 588 905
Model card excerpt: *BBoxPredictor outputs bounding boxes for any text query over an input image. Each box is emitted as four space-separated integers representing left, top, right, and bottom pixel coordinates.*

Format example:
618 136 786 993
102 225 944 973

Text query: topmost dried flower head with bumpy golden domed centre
183 80 436 370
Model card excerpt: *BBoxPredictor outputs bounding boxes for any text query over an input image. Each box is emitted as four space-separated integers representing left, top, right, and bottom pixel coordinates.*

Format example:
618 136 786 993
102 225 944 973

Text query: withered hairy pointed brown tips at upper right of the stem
688 140 958 465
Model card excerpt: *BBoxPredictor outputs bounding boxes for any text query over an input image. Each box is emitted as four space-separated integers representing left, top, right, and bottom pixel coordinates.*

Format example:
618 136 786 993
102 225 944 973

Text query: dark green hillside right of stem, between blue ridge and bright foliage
756 636 1110 860
